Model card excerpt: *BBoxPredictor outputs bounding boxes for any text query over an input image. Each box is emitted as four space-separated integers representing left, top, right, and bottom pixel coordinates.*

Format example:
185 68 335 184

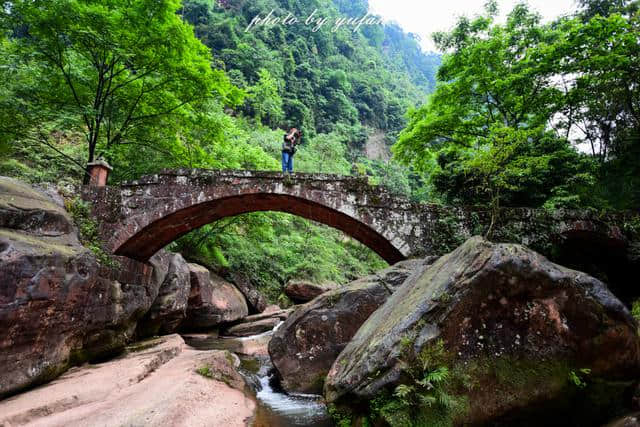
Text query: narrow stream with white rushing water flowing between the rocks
184 325 334 427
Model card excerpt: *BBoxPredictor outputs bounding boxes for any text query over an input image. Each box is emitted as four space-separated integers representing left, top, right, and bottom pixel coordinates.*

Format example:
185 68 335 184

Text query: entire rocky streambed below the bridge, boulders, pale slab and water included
0 178 640 427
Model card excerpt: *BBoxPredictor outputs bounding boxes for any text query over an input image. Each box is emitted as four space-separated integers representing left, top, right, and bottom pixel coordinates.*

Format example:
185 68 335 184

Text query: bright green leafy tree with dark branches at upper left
0 0 242 181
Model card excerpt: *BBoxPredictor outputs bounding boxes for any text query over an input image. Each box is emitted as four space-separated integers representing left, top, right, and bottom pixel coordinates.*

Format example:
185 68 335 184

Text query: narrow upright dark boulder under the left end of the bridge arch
138 254 191 337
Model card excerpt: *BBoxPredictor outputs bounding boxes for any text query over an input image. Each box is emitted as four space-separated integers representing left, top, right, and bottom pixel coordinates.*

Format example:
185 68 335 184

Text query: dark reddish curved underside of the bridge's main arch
114 193 405 264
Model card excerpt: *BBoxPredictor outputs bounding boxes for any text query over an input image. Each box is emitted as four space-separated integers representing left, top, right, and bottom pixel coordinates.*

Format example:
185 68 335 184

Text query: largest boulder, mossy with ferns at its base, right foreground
324 238 640 425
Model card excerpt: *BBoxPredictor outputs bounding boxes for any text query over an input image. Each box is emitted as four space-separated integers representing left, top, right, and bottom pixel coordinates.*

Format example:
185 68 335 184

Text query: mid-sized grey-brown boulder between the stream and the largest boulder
269 260 425 393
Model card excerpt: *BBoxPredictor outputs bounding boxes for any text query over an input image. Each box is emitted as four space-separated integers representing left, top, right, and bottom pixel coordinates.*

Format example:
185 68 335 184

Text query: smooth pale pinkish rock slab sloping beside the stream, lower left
0 335 255 427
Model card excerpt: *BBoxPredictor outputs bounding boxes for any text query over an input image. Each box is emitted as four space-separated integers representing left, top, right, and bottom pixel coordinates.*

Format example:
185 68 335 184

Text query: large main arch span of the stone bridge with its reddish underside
83 170 422 264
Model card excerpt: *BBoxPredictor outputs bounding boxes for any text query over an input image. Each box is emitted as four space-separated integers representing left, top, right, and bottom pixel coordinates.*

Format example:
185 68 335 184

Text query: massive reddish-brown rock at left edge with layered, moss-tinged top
0 178 159 397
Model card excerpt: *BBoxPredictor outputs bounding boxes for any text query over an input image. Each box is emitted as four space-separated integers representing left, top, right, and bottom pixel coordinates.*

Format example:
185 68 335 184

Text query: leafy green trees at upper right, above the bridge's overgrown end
393 2 640 211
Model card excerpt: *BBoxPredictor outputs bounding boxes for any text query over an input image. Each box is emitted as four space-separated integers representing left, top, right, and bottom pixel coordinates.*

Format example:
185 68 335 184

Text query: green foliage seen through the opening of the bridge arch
171 212 386 305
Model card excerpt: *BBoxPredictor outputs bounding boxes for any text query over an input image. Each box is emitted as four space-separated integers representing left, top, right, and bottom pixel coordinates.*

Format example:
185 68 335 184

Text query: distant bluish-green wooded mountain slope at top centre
182 0 439 136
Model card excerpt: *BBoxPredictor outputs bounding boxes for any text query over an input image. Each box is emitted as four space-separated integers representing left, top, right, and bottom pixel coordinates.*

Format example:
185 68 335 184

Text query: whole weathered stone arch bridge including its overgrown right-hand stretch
77 170 629 270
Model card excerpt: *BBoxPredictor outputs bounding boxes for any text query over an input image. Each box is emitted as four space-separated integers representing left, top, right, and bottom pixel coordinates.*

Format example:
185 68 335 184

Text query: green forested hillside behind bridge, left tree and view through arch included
0 0 440 299
